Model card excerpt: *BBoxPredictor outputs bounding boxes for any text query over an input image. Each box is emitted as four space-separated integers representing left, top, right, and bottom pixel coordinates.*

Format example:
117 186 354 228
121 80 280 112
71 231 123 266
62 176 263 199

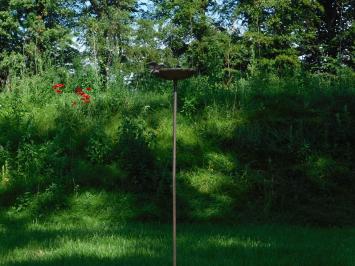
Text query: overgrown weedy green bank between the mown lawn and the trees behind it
0 67 355 225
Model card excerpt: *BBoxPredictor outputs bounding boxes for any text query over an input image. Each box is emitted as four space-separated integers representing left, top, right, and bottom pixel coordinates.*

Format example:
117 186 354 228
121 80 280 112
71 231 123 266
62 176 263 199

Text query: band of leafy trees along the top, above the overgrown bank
0 0 355 82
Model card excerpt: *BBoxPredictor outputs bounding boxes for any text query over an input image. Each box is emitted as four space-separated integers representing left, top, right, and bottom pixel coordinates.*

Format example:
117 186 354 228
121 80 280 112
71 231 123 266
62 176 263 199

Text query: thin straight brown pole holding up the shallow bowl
173 80 177 266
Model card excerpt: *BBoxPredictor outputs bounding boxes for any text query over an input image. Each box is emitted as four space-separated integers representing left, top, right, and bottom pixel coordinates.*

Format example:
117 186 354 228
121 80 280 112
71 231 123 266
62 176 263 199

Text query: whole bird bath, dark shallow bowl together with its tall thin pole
149 62 196 266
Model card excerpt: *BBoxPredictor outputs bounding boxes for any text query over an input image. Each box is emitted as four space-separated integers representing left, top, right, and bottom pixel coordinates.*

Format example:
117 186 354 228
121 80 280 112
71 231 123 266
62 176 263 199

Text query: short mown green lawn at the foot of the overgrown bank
0 210 355 266
